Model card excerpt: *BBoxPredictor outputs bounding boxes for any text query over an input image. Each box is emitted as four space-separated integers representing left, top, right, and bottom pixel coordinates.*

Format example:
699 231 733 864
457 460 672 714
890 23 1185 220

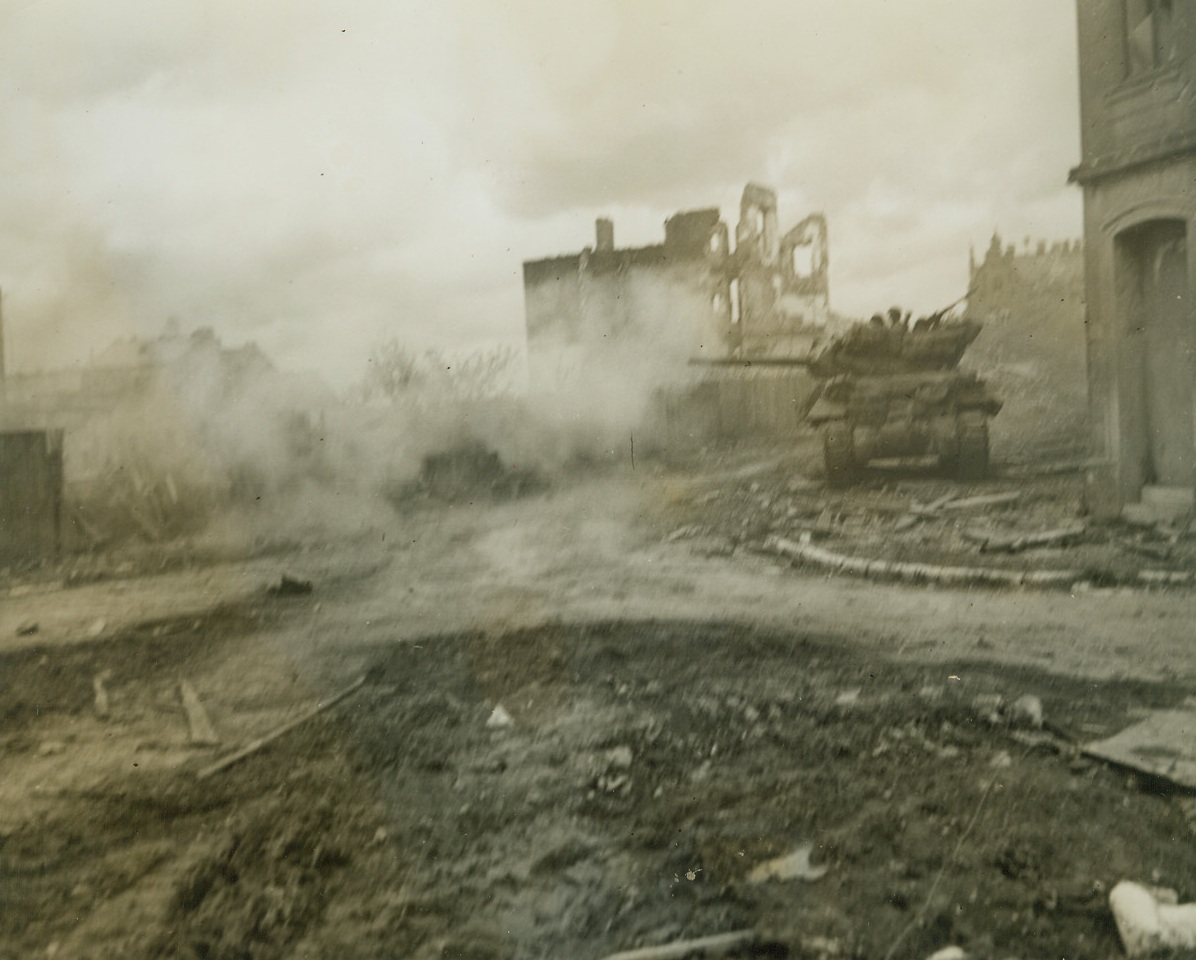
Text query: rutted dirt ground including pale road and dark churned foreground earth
0 463 1196 958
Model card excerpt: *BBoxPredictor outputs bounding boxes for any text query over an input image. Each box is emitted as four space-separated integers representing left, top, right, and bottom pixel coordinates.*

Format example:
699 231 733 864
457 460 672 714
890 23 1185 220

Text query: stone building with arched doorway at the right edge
1072 0 1196 516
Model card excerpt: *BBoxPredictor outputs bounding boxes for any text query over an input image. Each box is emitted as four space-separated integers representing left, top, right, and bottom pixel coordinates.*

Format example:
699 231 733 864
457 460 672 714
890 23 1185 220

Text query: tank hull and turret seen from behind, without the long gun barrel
808 308 1001 485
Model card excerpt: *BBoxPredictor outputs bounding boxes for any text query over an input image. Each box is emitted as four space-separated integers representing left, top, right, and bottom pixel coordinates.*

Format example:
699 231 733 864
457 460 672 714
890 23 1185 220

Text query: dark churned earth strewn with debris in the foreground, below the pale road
0 623 1196 960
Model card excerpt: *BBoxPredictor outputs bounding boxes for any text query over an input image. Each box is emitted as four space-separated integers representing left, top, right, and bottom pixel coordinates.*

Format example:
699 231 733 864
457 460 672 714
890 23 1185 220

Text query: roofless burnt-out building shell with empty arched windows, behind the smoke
524 184 830 391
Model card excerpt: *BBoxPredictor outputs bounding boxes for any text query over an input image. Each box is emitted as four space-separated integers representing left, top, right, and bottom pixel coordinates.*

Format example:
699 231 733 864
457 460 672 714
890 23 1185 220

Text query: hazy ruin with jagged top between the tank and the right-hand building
964 233 1088 463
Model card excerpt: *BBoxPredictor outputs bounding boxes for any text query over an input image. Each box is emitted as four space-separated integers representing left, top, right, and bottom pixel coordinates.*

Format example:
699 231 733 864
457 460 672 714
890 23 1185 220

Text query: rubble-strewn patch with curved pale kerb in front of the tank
658 449 1196 587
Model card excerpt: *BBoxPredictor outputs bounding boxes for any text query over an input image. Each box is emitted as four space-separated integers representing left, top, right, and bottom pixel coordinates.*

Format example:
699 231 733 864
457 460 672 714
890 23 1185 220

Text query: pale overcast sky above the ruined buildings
0 0 1080 385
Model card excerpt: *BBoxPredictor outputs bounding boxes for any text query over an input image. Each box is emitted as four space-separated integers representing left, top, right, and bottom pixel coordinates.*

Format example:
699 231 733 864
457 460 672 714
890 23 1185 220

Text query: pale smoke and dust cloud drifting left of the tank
56 315 687 552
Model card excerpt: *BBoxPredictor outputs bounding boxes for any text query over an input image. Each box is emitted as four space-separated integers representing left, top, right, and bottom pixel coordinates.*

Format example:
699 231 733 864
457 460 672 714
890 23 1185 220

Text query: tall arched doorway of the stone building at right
1118 220 1196 488
